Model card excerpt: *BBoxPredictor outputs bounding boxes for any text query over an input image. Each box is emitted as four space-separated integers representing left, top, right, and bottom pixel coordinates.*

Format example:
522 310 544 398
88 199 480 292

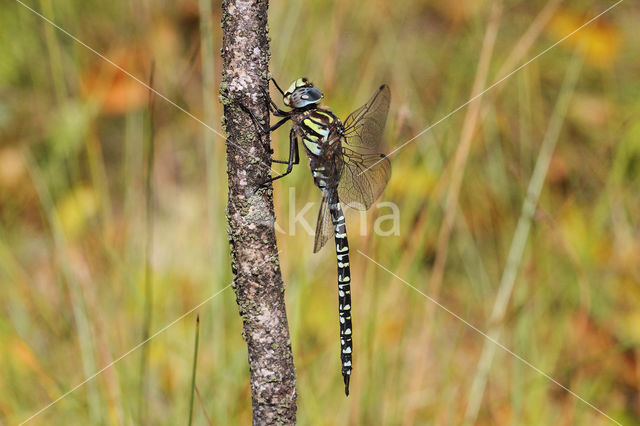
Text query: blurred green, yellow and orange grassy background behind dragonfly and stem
0 0 640 425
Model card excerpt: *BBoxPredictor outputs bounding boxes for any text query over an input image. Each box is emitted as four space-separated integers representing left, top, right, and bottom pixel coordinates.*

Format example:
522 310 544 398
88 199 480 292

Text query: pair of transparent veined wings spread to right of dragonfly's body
337 85 391 210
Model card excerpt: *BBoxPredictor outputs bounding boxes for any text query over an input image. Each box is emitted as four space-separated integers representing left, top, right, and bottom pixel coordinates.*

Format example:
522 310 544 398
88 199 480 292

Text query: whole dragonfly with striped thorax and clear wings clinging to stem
243 78 391 396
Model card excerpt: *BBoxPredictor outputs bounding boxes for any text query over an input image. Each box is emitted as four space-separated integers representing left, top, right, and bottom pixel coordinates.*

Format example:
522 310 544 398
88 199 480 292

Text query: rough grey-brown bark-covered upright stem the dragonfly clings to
220 0 296 424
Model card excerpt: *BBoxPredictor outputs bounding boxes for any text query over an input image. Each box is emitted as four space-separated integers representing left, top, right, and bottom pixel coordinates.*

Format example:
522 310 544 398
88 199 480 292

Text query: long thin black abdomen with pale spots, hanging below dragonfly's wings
329 189 353 395
